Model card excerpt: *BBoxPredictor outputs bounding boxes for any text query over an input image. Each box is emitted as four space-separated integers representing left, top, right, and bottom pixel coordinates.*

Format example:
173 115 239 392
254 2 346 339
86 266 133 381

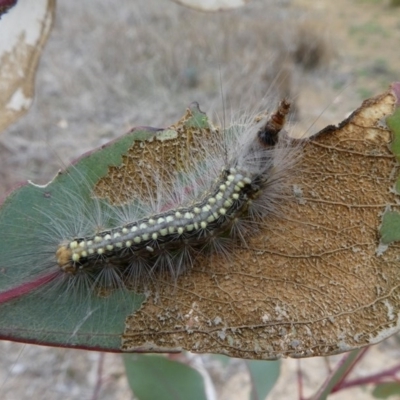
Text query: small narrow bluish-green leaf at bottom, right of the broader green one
246 360 281 400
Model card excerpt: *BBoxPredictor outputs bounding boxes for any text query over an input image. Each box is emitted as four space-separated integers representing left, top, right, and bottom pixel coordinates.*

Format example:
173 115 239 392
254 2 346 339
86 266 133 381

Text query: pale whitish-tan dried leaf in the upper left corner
0 0 55 131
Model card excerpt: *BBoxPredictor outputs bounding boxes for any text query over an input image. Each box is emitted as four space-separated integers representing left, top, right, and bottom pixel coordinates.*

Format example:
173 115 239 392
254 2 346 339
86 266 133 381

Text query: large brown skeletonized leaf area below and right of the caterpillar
122 87 400 359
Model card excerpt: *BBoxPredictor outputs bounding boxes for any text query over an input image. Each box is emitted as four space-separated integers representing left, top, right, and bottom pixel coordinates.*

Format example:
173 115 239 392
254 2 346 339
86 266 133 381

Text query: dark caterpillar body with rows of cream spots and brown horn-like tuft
56 101 290 280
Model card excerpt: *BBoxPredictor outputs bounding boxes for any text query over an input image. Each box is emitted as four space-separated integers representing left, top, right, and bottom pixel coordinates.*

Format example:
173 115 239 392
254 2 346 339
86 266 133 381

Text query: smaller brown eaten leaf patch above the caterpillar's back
95 103 211 204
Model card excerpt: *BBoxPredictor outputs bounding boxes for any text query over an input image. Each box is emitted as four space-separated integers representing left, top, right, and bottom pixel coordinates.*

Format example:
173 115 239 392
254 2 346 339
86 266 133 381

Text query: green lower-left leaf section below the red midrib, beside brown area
0 290 145 351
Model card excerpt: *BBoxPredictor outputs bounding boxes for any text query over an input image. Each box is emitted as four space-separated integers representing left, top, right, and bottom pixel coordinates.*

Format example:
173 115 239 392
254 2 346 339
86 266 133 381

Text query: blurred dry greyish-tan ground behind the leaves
0 0 400 400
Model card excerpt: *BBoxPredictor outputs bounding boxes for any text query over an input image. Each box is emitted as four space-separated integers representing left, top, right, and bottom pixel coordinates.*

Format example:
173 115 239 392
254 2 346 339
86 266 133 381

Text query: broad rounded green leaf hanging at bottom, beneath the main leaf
124 354 207 400
